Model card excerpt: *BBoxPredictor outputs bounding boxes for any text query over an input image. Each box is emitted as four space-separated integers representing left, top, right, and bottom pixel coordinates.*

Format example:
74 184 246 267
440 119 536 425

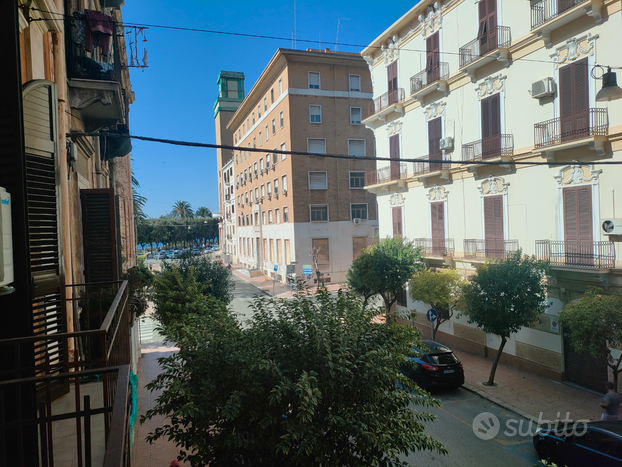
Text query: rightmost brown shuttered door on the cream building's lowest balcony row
563 186 594 266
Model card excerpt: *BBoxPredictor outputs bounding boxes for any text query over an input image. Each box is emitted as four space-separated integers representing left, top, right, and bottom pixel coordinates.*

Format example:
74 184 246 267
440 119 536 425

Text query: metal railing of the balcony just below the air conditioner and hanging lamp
534 109 609 148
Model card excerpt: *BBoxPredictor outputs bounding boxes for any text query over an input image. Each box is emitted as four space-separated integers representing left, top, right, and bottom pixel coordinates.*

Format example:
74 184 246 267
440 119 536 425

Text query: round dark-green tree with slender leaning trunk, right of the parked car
461 250 549 386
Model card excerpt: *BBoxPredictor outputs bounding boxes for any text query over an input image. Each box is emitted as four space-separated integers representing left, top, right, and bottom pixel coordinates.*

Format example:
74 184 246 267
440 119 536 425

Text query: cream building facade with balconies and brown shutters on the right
362 0 622 390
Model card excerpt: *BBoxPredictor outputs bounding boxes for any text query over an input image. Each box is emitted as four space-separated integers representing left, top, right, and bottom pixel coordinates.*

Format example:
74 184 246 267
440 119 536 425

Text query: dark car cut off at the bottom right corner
533 421 622 467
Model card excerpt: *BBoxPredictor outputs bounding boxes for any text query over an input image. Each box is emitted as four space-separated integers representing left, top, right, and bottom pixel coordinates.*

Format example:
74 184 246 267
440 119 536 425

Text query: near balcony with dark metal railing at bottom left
0 281 131 467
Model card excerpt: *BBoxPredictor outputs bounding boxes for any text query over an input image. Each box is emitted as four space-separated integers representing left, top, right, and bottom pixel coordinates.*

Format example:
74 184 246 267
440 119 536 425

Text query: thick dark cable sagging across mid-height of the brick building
67 131 622 166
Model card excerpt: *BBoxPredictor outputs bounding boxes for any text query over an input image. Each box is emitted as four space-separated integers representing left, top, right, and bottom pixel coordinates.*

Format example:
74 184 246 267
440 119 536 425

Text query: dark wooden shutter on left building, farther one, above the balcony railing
80 188 119 283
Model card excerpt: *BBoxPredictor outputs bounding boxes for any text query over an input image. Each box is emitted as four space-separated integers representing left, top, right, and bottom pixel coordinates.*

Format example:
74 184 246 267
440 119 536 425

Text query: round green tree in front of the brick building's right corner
347 237 424 314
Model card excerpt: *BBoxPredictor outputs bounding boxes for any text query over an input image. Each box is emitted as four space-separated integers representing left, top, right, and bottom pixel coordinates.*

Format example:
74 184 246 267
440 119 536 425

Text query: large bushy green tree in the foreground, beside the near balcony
143 288 447 467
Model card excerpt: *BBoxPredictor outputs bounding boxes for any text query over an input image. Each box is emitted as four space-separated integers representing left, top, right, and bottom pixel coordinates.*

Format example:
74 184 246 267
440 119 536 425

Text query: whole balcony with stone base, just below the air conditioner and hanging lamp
534 109 609 161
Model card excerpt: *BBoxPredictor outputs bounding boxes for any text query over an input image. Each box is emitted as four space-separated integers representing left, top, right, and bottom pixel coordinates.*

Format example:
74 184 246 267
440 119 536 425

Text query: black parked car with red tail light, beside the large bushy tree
401 341 464 389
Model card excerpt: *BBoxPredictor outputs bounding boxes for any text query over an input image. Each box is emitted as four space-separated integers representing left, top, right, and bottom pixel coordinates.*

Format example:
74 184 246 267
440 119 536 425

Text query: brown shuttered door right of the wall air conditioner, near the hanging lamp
559 58 590 142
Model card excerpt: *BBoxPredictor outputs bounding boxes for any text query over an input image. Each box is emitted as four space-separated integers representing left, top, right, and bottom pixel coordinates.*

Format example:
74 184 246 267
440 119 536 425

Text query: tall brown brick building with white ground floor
227 49 378 282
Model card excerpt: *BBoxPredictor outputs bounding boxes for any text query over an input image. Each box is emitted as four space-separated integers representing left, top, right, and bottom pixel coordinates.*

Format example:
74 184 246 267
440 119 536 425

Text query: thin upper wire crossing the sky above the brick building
30 8 622 70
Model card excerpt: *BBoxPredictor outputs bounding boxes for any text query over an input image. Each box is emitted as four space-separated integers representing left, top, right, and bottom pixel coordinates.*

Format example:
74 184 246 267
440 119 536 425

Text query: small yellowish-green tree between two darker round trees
410 269 463 334
